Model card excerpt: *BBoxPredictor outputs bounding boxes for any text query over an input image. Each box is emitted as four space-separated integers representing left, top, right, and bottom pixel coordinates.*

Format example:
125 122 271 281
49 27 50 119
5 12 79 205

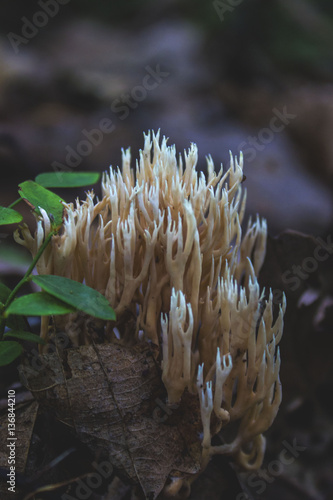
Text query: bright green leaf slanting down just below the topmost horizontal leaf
19 181 64 230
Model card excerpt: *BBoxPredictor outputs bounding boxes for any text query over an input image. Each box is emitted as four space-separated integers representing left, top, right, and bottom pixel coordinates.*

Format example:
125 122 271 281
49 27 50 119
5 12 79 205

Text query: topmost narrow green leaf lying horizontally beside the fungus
35 172 101 188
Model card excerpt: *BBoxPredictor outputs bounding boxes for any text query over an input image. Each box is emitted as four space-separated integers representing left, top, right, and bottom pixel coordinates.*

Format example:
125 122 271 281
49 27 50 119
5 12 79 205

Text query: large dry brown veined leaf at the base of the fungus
20 343 202 499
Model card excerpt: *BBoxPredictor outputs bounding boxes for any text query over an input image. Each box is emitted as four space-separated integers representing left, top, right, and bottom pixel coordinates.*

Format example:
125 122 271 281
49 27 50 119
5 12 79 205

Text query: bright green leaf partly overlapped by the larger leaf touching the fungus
5 292 75 316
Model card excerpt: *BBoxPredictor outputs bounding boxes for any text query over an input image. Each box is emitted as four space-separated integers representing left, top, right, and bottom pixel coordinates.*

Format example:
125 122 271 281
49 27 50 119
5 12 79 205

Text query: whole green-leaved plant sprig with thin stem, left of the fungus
0 172 115 366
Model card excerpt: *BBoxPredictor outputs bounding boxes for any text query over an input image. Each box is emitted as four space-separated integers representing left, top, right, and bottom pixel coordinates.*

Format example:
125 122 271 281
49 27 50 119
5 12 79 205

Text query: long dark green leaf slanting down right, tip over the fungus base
32 275 116 320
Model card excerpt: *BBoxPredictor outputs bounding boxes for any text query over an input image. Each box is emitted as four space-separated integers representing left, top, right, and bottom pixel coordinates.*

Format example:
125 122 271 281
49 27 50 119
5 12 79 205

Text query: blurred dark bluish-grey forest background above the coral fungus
0 0 333 234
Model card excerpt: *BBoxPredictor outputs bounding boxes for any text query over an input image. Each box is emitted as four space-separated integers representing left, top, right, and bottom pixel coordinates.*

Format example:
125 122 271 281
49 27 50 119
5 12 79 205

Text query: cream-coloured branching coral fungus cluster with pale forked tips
16 129 285 468
